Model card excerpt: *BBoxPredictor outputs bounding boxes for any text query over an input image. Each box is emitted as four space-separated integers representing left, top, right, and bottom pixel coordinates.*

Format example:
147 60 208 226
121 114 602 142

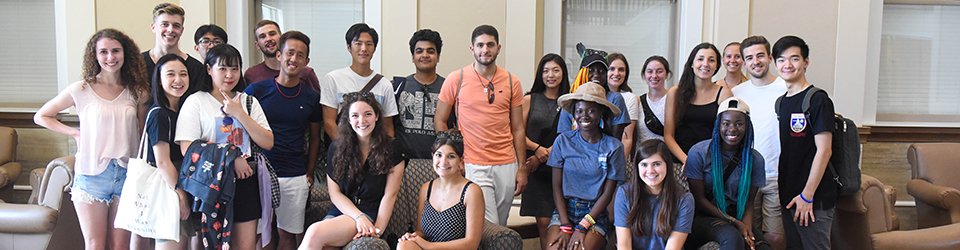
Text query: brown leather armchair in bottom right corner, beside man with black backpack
830 175 960 250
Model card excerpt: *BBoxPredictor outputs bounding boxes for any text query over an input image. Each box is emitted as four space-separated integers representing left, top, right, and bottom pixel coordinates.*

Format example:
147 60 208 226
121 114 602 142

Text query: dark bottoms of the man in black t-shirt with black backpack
781 207 833 249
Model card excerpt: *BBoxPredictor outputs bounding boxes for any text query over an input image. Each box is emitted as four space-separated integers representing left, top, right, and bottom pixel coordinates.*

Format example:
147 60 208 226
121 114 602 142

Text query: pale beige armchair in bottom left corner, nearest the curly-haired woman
0 156 83 250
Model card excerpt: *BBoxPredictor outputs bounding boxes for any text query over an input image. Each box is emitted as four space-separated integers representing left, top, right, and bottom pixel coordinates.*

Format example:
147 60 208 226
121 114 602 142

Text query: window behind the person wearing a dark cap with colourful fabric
563 0 677 93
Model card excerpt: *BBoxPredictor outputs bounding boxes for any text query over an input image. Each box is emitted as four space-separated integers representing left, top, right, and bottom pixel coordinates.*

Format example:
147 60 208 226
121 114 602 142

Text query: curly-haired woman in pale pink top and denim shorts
33 29 149 249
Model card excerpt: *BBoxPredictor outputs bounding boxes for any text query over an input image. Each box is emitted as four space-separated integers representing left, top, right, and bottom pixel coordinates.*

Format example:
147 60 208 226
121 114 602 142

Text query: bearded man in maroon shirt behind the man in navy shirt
242 20 320 92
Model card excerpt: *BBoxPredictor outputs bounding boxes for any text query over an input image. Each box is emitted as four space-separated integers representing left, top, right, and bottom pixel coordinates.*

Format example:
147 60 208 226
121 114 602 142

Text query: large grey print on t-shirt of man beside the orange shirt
398 91 440 134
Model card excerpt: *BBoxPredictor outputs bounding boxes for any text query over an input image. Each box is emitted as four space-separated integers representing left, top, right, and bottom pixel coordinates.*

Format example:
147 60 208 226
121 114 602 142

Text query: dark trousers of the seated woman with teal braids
685 214 770 250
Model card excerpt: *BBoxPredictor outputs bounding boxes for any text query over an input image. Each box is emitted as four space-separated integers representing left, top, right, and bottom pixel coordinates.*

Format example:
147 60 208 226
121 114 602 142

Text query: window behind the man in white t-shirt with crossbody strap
261 0 363 78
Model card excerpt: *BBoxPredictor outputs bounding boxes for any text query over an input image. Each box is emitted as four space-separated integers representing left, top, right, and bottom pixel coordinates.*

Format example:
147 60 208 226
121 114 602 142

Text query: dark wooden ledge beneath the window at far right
858 126 960 142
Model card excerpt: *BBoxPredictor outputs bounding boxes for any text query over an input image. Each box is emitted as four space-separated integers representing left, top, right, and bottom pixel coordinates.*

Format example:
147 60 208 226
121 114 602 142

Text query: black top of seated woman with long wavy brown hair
327 140 403 215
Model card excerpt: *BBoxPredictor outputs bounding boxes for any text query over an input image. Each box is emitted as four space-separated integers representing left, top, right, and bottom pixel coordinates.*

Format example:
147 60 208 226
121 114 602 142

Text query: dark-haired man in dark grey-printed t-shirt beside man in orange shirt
394 29 454 159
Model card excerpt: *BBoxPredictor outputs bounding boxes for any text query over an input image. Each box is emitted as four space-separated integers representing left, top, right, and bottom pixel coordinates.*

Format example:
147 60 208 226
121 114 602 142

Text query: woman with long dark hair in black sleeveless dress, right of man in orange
520 53 570 249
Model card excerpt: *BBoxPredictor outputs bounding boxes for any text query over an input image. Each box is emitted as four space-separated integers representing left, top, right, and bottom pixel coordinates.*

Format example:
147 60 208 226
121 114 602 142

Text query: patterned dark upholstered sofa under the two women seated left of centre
304 159 523 250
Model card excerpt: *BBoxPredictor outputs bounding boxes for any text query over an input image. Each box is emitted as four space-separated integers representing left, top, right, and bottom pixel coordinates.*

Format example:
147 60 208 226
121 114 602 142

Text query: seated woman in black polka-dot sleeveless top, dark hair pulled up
397 132 483 249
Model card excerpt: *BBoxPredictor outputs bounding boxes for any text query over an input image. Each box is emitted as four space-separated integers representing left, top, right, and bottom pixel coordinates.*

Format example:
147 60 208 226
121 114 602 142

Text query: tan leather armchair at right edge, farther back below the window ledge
907 143 960 228
